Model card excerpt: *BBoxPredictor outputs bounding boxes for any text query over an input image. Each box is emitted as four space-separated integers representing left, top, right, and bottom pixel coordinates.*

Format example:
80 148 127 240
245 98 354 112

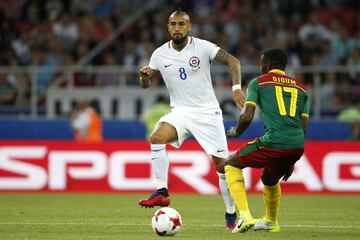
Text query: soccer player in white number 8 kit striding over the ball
139 9 245 229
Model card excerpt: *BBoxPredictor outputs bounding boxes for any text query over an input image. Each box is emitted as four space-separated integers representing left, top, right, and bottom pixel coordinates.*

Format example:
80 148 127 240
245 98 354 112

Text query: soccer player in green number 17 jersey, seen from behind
225 49 309 233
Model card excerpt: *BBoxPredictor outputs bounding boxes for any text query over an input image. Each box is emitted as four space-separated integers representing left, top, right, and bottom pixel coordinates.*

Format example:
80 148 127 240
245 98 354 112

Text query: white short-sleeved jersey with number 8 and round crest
149 37 220 110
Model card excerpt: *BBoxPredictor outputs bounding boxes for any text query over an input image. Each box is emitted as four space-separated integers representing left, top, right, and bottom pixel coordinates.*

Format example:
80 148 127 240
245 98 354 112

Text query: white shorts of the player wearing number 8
158 108 228 158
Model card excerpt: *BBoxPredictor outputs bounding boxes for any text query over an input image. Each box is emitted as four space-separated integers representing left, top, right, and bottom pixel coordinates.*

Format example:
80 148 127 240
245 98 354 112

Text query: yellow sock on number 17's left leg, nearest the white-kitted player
225 165 249 214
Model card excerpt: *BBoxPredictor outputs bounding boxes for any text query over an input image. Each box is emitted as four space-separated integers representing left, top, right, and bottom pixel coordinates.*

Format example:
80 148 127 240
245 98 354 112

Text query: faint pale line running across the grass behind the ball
0 222 360 229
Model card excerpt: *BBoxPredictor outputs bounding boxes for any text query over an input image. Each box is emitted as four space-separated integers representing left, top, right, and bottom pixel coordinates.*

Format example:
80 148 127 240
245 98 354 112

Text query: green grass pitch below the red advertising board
0 193 360 240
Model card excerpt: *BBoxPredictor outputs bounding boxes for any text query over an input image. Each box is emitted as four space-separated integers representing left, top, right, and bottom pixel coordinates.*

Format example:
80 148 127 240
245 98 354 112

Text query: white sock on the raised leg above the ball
150 144 169 189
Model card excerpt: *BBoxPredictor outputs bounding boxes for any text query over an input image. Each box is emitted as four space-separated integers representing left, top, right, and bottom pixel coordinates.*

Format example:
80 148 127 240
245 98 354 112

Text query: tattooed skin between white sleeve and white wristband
214 48 241 85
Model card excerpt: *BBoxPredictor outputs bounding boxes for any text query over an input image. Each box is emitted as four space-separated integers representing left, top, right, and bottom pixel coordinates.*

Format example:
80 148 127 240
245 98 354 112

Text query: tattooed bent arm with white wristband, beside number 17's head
214 49 245 107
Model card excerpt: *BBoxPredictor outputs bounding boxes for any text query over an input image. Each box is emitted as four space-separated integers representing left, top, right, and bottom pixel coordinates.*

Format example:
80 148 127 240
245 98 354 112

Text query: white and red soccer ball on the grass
151 207 182 236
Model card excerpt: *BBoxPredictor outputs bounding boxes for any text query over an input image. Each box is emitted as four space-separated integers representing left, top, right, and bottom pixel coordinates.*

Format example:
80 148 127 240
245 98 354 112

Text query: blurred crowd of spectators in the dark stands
0 0 360 118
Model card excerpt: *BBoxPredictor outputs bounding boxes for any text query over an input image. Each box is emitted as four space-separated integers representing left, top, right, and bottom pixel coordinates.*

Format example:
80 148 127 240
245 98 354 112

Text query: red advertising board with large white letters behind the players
0 141 360 194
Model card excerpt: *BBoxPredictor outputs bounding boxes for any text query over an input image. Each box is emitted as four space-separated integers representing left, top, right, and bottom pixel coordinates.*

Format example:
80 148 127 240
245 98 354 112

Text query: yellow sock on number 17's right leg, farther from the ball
263 183 281 221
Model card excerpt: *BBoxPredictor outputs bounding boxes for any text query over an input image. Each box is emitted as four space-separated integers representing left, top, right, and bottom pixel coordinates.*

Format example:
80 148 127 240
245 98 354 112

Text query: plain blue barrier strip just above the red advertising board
0 120 351 141
